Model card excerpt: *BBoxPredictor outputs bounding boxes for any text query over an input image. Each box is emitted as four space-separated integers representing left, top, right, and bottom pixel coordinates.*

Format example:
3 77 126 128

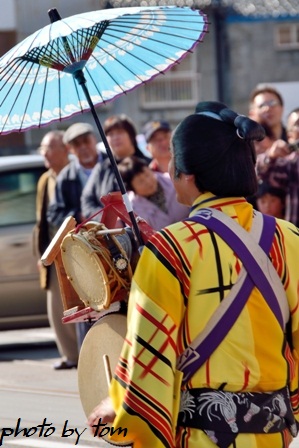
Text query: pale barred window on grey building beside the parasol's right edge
139 54 201 109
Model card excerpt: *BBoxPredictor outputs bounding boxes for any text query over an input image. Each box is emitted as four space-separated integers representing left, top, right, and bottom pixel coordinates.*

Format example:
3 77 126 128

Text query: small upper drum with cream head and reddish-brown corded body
61 222 132 311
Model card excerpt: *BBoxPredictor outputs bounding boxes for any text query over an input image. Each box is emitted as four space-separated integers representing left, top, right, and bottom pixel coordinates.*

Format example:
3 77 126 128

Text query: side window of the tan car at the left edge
0 167 44 227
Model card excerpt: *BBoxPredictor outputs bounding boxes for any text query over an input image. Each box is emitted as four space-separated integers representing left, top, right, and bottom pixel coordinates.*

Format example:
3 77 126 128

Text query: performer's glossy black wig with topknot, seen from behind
172 102 265 197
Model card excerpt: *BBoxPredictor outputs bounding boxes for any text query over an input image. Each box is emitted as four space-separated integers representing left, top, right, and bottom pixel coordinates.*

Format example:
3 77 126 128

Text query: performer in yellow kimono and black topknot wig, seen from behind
88 102 299 448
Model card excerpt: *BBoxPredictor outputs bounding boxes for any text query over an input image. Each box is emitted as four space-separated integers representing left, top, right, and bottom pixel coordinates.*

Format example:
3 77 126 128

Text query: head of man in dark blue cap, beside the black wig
143 120 171 173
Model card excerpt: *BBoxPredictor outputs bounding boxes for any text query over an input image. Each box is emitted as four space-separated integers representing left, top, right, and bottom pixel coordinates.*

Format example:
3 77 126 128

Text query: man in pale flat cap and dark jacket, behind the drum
48 123 105 349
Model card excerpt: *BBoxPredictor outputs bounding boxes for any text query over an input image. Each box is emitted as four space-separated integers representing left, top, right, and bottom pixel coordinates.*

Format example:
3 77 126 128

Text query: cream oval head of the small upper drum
61 234 110 311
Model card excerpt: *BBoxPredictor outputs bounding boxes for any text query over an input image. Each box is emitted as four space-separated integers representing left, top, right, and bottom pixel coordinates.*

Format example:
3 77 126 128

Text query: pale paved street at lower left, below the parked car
0 328 299 448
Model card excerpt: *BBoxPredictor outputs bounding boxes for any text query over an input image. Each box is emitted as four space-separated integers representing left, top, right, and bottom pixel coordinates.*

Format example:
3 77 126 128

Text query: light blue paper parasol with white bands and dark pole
0 6 207 243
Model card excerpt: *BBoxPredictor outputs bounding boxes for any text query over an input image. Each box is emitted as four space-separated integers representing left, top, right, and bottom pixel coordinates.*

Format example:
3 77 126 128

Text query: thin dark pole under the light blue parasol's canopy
73 70 144 246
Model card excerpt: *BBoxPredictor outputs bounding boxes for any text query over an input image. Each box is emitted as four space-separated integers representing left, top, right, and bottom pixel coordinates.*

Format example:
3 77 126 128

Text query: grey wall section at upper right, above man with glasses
227 20 299 118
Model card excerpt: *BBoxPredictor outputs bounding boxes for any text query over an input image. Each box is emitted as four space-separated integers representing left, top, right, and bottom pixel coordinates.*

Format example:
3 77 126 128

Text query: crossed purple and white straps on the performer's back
177 208 289 384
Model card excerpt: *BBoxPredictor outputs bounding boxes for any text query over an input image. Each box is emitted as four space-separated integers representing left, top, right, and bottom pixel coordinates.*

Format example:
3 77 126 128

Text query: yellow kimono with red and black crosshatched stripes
110 193 299 448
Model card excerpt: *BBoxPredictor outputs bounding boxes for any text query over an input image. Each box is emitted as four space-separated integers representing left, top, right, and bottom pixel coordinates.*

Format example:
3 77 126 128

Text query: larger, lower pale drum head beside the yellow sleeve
78 313 127 417
